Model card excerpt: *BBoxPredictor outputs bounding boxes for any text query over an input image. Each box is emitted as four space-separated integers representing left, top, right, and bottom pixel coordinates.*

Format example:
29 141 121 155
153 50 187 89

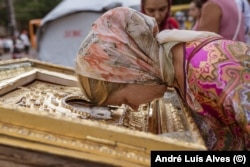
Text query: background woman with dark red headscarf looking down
141 0 179 31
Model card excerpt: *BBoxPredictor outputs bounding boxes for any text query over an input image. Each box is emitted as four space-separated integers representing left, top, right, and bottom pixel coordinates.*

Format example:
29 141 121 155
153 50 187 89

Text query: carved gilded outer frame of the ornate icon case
0 58 206 166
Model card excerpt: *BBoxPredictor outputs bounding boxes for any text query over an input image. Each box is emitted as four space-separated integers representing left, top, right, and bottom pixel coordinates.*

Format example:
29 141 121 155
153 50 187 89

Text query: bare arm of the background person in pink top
197 2 222 34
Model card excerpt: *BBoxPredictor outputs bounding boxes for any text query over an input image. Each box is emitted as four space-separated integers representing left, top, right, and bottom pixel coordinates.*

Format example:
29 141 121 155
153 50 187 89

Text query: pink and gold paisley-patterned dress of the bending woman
184 39 250 150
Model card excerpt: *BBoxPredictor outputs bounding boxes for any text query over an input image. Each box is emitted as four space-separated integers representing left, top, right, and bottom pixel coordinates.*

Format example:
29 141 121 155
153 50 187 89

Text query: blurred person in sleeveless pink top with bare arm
197 0 246 42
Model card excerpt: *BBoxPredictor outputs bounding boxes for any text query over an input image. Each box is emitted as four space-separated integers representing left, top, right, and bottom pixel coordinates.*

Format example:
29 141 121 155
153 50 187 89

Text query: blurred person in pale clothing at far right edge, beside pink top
235 0 250 44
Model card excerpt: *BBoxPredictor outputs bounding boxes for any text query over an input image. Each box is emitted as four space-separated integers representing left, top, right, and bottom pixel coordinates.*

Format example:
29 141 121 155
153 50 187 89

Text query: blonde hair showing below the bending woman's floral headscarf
77 75 127 106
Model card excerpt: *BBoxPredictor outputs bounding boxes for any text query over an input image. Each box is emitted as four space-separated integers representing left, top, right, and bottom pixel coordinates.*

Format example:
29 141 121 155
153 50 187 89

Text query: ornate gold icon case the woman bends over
0 59 206 166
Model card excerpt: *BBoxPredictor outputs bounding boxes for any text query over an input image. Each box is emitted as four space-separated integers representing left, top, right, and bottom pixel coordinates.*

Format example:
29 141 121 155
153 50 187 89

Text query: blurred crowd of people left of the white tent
0 30 30 59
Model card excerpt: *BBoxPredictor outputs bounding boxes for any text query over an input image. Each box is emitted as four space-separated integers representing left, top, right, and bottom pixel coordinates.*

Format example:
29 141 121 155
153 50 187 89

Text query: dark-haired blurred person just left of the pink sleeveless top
188 0 203 30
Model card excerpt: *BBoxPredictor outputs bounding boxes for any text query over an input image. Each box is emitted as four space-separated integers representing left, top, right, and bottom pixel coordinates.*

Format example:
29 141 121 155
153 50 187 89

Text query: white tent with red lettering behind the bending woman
37 0 140 67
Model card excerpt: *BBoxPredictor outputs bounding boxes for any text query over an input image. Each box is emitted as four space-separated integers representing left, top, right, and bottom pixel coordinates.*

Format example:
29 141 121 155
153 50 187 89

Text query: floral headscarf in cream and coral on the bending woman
76 7 220 85
